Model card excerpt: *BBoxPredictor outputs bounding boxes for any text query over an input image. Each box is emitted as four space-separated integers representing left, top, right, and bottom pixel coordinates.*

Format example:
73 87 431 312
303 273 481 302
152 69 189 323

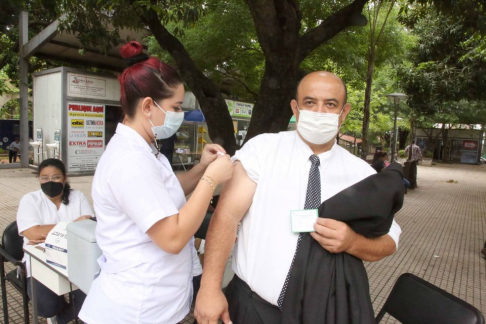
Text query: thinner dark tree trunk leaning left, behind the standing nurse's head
141 9 237 155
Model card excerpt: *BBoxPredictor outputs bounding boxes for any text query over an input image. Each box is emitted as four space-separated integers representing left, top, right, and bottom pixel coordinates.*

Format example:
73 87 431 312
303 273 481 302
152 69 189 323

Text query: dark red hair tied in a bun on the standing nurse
118 42 183 118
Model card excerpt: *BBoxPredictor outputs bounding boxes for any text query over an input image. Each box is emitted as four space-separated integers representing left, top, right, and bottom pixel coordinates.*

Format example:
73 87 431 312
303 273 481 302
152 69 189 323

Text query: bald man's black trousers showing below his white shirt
225 275 282 324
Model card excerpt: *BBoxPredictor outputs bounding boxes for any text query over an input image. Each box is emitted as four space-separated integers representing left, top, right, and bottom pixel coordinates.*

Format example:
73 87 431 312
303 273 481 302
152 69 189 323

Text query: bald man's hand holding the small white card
310 217 358 253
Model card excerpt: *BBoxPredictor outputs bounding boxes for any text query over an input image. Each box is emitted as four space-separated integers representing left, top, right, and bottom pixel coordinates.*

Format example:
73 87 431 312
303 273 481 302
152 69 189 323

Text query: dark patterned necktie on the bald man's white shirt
277 154 321 309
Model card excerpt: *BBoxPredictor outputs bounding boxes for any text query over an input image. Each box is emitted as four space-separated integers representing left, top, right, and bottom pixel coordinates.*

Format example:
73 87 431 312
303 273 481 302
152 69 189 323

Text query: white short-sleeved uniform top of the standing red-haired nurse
79 124 196 324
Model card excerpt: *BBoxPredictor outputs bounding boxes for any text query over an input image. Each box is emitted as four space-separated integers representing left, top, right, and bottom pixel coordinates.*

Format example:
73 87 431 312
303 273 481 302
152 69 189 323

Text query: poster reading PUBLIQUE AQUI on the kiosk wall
67 102 105 172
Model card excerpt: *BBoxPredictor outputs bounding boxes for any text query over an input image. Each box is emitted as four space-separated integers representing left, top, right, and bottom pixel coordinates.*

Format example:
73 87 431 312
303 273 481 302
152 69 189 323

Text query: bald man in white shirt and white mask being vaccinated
195 72 401 324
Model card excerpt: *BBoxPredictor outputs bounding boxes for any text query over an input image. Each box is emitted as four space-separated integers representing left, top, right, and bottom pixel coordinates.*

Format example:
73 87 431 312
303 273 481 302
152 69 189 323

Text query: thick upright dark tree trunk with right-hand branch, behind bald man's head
245 0 368 142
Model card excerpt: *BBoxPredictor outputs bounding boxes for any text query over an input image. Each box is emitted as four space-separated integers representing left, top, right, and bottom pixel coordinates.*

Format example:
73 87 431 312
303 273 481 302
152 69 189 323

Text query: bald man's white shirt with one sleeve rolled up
233 131 401 305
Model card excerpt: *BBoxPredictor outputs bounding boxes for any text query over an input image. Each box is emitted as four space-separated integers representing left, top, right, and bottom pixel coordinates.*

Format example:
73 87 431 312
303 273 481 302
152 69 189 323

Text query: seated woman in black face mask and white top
17 159 94 324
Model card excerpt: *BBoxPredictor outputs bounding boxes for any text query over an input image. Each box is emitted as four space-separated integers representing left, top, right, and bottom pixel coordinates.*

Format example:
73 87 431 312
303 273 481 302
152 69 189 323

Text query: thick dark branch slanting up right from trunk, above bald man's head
298 0 369 62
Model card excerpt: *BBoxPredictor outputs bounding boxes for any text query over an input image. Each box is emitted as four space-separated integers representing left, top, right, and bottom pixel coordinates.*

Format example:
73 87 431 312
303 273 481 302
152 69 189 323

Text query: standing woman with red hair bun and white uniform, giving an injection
79 42 233 324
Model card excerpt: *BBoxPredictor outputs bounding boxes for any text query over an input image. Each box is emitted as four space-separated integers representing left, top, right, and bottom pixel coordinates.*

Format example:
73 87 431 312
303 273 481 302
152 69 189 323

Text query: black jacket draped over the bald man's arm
282 163 405 324
